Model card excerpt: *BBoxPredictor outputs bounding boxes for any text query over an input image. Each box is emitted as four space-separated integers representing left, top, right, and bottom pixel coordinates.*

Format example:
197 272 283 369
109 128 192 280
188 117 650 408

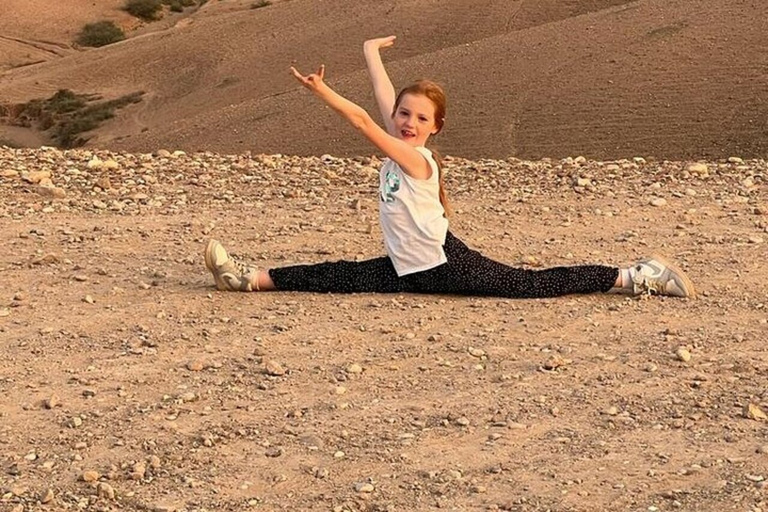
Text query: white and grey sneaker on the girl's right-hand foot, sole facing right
629 256 696 298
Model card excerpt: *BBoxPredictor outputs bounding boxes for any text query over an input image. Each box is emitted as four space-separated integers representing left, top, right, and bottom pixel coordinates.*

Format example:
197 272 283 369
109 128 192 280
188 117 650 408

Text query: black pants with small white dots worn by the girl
269 232 619 298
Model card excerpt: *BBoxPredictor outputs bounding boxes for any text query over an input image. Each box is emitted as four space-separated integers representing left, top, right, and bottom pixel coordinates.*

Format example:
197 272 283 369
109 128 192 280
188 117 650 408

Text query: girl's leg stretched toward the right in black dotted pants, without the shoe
404 232 620 298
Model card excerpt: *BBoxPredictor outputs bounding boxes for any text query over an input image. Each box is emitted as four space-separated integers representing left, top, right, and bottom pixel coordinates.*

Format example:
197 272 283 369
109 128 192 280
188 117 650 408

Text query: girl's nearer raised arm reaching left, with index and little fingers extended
291 66 432 180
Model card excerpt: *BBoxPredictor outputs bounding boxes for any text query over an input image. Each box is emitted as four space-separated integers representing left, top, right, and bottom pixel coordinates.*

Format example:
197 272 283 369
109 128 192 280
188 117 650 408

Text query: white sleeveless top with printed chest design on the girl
379 147 448 276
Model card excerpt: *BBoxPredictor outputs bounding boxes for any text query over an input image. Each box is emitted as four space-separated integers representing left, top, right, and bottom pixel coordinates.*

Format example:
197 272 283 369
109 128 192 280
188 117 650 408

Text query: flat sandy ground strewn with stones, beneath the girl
0 147 768 512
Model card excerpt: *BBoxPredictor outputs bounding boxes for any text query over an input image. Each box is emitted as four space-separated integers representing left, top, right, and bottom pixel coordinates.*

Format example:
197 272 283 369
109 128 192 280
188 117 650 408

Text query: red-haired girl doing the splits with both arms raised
205 36 696 298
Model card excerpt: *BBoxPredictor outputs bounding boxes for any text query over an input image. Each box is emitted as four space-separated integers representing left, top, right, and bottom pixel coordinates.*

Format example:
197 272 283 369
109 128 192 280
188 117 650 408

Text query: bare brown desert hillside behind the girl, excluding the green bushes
0 0 768 159
